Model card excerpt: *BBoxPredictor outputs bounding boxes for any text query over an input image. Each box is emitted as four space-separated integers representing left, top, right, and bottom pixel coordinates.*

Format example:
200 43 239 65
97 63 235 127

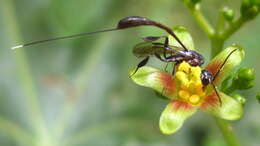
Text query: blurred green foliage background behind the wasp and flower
0 0 260 146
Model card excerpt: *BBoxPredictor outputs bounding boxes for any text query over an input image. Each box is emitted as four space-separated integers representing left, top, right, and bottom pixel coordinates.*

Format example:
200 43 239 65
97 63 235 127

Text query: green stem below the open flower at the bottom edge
214 117 240 146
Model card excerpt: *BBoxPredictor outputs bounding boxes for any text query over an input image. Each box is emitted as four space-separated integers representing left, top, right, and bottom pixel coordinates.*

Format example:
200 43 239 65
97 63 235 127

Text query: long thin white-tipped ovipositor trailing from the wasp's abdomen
11 28 120 50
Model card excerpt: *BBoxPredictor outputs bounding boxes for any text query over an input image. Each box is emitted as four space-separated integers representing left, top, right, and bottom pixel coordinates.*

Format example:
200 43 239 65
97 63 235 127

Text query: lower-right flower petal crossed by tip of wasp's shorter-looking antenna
201 91 243 120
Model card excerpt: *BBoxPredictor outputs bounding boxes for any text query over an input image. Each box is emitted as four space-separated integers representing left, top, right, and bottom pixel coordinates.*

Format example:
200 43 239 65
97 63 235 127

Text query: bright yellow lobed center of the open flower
176 61 205 105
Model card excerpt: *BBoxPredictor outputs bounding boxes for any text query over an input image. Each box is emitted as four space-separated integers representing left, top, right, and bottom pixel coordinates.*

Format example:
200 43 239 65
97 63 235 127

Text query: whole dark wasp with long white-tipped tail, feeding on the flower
12 16 236 105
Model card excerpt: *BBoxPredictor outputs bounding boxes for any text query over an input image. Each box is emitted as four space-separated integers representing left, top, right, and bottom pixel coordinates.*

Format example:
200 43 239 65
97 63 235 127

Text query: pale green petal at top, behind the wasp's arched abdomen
169 26 195 50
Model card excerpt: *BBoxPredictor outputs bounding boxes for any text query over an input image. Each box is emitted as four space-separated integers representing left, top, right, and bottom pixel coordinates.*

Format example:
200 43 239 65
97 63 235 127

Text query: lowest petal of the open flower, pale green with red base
160 101 197 134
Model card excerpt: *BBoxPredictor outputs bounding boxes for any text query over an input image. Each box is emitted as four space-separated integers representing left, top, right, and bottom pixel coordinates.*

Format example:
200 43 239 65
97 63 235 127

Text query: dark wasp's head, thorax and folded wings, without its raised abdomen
133 34 214 86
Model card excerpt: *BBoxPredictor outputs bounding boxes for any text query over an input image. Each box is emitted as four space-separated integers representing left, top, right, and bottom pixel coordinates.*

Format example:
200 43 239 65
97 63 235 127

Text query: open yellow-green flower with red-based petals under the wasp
130 28 244 134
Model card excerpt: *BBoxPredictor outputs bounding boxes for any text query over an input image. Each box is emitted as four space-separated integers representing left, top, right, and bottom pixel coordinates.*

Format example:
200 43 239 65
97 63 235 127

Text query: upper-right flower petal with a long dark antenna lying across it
206 45 245 86
